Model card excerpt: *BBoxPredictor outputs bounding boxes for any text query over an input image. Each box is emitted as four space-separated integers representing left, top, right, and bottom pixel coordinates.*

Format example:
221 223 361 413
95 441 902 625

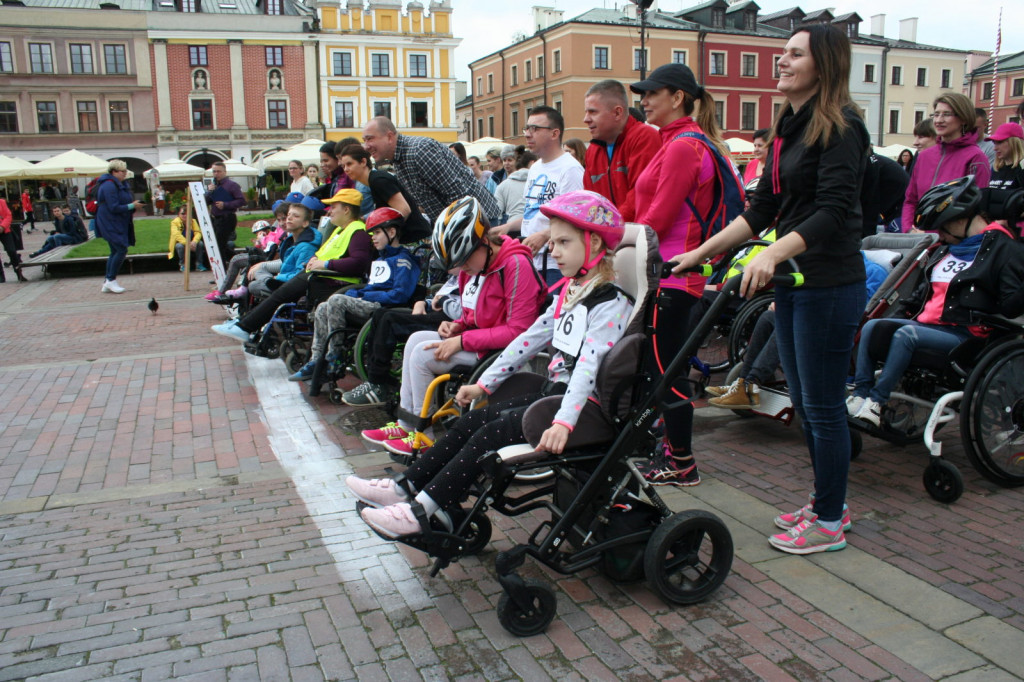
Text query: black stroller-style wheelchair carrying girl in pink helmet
360 224 770 636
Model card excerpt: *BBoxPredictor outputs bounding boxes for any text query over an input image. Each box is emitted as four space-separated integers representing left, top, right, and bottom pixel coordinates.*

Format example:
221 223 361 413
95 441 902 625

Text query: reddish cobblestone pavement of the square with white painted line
0 272 1024 682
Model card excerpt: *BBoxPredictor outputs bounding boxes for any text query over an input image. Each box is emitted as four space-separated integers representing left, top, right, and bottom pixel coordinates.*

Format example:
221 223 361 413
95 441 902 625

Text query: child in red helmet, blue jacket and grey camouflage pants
289 207 420 381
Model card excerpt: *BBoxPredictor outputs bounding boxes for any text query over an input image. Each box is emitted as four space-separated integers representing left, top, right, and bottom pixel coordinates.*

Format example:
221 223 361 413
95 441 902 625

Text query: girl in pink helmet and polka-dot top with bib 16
346 190 633 538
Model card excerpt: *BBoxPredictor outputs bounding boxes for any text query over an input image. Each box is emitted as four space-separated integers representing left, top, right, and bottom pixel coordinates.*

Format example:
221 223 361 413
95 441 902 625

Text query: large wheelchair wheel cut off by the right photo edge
961 339 1024 487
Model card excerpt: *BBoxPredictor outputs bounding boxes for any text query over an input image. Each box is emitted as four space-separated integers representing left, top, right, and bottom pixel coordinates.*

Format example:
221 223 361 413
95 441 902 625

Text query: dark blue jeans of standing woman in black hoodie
775 282 867 521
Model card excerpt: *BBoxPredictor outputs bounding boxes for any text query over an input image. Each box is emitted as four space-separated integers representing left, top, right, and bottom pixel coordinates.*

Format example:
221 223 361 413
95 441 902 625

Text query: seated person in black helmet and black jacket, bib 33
847 175 1024 427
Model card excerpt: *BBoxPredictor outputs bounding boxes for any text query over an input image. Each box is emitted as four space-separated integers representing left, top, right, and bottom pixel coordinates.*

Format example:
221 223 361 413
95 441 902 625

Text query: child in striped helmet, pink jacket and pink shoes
361 197 547 456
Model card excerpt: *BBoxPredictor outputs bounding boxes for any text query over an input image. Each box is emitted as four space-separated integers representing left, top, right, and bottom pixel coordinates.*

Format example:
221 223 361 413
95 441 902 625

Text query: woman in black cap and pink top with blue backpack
630 63 728 485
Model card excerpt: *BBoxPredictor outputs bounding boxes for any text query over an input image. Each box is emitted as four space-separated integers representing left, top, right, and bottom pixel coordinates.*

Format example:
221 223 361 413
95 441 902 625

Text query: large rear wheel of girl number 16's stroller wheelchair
643 509 732 604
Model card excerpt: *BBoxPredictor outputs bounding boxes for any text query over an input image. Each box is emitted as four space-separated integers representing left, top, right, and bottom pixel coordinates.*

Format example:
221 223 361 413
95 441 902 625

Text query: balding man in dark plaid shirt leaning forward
362 116 502 225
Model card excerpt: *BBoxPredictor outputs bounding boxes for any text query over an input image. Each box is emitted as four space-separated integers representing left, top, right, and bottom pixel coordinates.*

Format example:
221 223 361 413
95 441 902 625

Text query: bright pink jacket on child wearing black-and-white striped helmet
448 237 547 356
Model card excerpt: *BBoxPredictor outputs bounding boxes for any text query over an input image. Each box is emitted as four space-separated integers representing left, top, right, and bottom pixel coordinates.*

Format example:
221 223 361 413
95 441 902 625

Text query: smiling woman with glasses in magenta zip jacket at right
901 92 992 232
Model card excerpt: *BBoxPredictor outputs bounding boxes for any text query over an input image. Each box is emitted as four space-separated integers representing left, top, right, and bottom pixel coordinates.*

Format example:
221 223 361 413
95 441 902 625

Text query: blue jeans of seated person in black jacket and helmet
853 319 971 403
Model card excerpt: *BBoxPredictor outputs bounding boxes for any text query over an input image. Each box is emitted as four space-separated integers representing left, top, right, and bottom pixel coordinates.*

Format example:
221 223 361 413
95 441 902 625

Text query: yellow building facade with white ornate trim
316 0 461 142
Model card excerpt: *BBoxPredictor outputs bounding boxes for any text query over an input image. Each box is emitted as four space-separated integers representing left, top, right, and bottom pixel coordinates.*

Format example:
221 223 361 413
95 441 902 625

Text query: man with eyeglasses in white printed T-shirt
493 106 583 285
